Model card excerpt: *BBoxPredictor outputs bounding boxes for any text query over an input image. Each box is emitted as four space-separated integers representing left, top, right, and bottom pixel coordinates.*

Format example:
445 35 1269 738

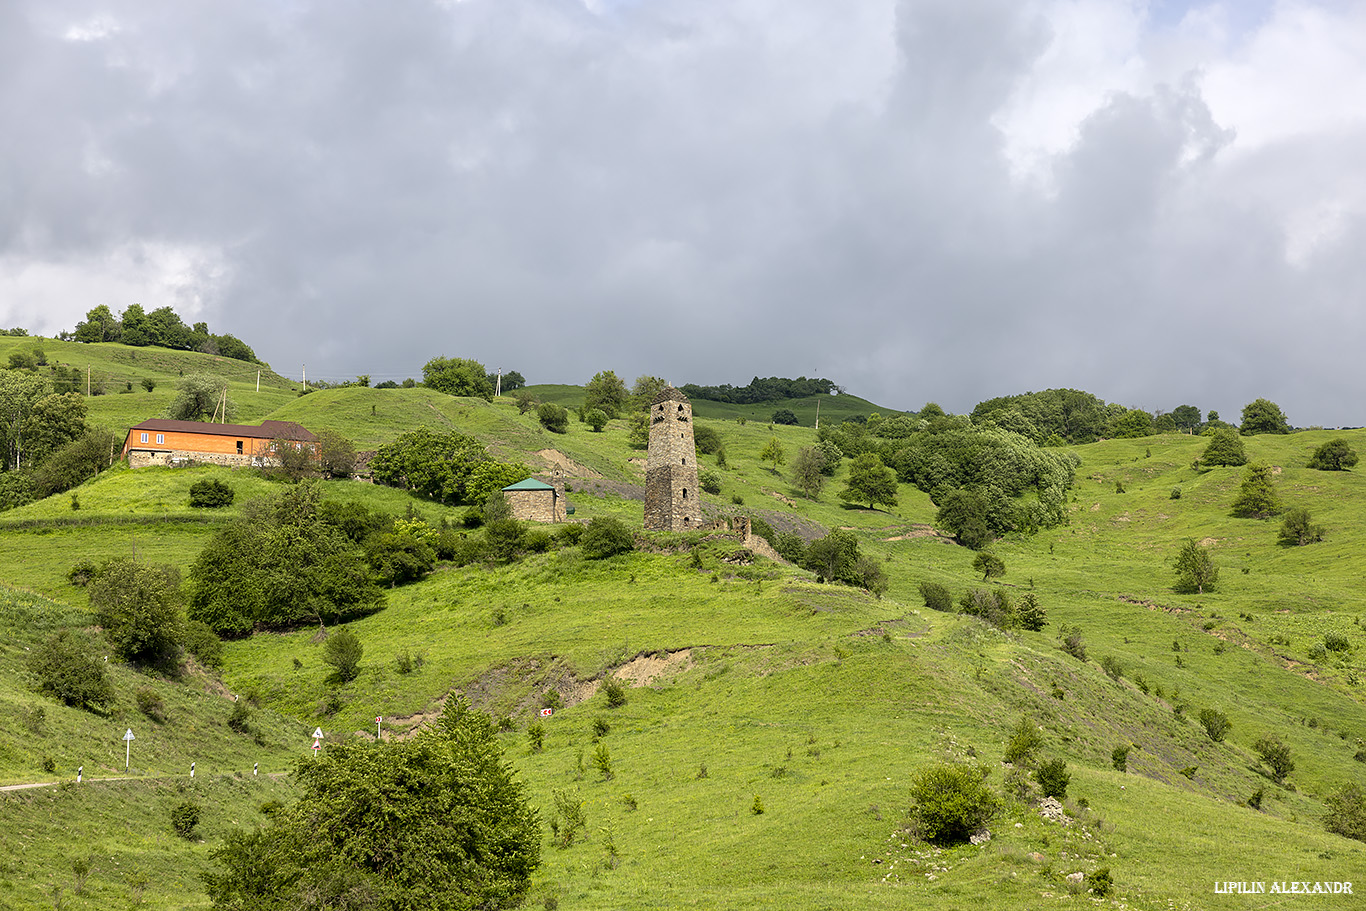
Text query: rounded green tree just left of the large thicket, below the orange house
89 560 184 668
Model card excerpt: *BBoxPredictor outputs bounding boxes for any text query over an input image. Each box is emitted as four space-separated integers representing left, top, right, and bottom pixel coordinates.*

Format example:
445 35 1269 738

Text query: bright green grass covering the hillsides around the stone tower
0 360 1366 908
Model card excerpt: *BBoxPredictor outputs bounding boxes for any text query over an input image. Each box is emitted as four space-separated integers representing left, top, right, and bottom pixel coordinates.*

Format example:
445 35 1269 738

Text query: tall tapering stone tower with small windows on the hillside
645 387 702 531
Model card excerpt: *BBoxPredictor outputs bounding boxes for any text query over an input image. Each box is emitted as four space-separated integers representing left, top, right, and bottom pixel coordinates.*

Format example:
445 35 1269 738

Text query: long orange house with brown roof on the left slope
123 418 318 468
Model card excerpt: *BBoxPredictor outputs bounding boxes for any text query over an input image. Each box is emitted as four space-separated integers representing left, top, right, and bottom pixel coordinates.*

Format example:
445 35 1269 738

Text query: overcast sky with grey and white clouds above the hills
0 0 1366 425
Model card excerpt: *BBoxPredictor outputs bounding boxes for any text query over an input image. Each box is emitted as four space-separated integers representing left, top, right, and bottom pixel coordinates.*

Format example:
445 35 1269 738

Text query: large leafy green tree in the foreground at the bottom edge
204 699 541 911
